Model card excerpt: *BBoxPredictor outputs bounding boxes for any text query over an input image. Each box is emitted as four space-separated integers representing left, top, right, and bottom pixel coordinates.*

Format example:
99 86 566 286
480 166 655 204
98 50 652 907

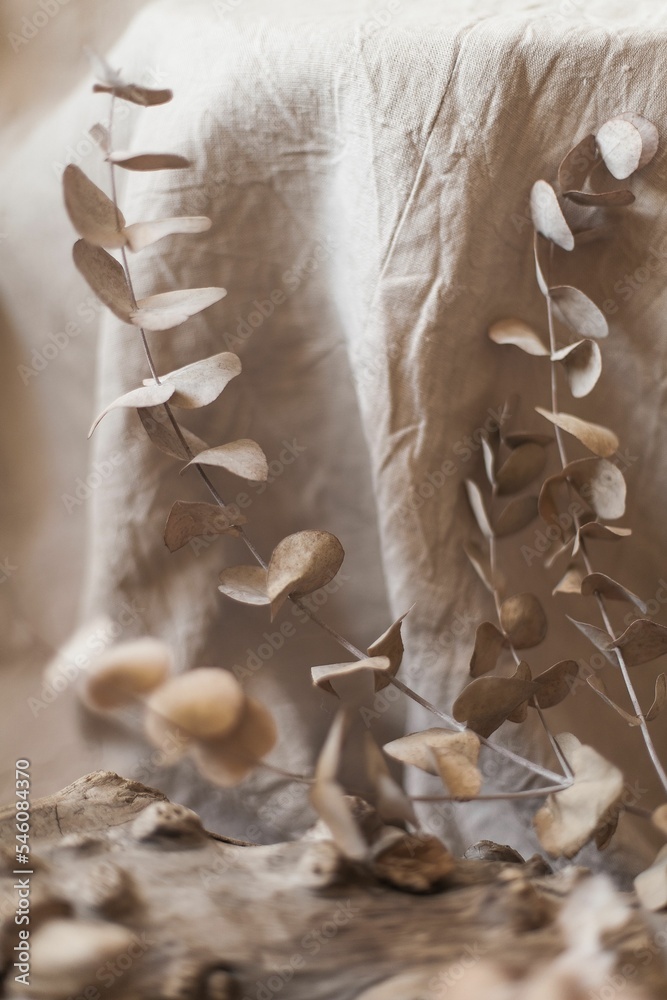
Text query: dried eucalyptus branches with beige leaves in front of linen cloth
64 60 667 905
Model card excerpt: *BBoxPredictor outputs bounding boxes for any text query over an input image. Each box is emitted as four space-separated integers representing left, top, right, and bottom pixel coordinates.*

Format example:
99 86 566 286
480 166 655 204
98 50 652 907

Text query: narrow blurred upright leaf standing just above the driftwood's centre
310 711 368 861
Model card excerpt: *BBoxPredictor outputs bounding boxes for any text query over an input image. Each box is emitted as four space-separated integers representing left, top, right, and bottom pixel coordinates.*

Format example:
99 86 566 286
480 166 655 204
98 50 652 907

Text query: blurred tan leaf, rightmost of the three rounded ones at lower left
192 697 277 788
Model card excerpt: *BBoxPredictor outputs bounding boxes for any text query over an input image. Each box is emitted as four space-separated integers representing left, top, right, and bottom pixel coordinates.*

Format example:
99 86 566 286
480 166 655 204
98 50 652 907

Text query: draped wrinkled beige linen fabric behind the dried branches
0 0 667 868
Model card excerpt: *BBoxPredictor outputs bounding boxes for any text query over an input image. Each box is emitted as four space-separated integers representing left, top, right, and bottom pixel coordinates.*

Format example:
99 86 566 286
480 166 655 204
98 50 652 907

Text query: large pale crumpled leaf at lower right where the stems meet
533 734 623 858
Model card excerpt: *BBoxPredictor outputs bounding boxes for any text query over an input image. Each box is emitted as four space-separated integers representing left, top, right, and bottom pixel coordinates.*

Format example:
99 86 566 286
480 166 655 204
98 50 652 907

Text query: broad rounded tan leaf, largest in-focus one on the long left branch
267 530 345 619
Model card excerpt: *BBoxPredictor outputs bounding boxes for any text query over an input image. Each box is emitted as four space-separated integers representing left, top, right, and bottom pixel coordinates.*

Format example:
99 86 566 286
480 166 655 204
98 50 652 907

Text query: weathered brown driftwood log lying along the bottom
0 772 667 1000
